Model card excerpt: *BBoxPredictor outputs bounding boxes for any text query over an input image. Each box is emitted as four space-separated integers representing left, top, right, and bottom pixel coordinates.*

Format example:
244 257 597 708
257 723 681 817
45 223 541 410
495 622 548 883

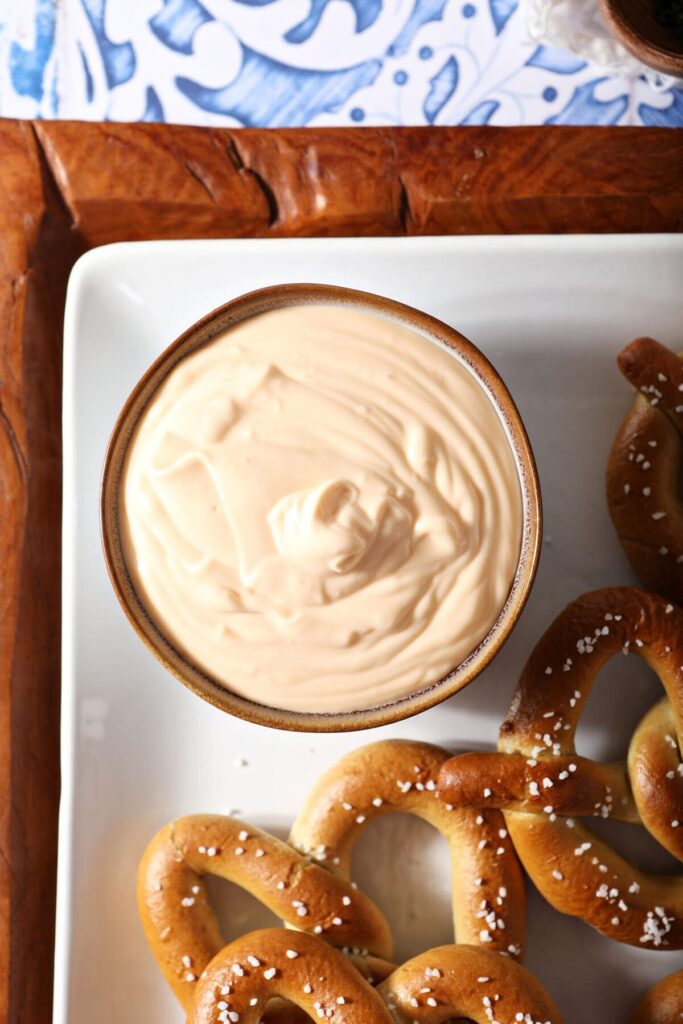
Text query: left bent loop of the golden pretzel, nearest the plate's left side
137 814 391 1010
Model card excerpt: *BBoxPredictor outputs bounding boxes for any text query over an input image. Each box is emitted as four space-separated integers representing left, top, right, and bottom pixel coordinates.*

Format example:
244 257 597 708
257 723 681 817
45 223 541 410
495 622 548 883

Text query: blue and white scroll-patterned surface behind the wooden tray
0 0 683 127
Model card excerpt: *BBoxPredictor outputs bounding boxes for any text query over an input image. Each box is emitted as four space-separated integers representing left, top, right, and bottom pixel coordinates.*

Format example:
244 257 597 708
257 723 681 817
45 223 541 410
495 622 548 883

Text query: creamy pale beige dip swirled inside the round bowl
120 304 522 713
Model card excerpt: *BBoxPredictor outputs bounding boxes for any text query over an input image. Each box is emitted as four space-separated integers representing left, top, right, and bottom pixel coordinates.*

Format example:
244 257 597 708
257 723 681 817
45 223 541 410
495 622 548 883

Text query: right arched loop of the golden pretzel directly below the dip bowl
290 739 526 956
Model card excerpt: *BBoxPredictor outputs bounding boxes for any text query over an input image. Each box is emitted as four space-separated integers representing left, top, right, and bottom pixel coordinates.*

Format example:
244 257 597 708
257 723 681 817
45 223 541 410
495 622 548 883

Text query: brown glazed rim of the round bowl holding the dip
100 285 542 732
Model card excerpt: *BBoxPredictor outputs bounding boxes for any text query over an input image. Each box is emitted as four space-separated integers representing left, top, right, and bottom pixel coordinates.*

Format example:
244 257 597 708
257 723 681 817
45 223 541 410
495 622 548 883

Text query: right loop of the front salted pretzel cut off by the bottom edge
378 944 562 1024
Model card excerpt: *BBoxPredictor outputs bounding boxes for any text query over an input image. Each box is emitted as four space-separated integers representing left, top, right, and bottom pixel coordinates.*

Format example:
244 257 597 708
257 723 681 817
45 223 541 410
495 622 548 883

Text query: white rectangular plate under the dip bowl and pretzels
54 236 683 1024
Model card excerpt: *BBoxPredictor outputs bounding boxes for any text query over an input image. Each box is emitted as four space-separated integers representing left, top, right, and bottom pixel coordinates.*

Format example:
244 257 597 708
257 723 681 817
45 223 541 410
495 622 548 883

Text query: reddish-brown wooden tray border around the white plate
0 121 683 1024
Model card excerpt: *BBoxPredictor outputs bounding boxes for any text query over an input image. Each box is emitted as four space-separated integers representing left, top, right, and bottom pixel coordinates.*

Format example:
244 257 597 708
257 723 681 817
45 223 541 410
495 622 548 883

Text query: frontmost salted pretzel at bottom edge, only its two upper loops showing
188 929 562 1024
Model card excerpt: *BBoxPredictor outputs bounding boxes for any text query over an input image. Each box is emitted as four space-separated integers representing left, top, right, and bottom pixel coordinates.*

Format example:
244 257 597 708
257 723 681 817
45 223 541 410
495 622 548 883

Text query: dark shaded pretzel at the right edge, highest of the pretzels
607 338 683 605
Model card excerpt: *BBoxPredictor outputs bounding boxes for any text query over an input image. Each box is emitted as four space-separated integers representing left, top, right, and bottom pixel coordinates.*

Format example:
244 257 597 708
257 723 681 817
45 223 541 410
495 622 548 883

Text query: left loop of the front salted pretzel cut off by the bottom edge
187 928 393 1024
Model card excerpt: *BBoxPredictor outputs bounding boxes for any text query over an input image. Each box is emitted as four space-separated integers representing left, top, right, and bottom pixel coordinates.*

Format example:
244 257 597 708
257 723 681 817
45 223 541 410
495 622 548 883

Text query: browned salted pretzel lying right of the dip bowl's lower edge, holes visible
439 587 683 949
